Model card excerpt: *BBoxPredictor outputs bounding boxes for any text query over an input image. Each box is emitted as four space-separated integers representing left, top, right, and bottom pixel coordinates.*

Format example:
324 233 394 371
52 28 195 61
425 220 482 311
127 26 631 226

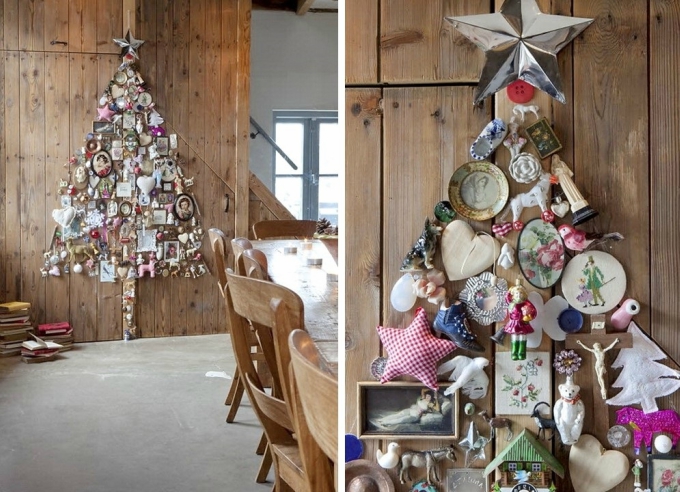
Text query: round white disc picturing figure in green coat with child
562 251 626 314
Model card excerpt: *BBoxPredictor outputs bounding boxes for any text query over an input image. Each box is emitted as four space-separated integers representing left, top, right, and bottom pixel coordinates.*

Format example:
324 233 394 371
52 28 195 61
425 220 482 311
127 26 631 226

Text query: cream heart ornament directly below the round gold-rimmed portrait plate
441 220 501 280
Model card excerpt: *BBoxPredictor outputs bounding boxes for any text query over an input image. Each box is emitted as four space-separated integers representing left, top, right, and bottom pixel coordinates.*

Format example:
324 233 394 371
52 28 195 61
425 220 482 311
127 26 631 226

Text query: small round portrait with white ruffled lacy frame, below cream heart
458 272 508 326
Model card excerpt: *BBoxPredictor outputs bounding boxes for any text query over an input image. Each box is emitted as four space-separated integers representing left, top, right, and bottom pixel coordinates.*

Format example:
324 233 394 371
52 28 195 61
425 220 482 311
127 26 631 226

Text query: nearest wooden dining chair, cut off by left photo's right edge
288 323 338 490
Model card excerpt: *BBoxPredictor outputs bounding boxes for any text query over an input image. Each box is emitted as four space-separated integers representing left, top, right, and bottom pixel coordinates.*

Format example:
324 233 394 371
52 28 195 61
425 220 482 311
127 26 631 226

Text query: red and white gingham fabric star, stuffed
378 307 456 389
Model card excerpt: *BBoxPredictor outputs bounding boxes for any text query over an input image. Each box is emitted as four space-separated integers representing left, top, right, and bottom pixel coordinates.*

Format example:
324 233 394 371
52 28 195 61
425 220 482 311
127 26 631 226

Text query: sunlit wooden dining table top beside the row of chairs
252 239 338 372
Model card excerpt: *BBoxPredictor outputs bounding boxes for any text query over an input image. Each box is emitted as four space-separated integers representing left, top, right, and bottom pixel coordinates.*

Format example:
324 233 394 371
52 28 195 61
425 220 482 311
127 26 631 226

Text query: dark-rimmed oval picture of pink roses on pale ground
517 219 564 289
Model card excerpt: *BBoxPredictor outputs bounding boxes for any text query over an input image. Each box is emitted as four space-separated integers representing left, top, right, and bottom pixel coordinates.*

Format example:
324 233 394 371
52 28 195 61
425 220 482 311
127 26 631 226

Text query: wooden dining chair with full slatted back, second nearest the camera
225 273 332 492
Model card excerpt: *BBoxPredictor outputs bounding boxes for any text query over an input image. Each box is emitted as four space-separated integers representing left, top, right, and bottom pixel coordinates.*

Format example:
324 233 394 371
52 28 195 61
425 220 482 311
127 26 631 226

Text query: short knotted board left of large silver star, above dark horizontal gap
380 0 489 83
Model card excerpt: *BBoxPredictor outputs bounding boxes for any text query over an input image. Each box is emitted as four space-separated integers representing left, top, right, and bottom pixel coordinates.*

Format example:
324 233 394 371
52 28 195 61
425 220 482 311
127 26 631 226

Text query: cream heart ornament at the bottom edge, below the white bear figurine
569 434 628 492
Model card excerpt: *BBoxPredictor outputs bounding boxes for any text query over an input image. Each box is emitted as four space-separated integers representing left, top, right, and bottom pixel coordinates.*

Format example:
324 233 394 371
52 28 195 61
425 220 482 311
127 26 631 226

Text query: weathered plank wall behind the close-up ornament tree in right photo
345 0 680 492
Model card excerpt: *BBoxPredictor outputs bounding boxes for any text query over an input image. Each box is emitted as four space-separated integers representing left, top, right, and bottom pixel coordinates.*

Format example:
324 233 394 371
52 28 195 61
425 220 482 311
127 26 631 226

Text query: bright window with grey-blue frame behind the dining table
274 111 342 225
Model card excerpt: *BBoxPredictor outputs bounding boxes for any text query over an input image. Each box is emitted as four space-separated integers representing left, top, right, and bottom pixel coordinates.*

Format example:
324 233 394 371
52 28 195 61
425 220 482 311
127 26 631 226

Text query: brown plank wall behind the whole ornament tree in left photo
0 0 251 341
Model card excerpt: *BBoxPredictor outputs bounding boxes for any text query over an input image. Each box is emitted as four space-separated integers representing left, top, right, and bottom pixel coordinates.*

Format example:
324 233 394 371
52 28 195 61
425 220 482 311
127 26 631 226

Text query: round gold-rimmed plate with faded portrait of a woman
449 161 509 220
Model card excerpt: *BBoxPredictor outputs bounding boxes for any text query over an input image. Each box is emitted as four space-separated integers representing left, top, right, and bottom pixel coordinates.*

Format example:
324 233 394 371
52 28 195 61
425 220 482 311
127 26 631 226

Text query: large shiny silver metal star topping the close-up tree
446 0 593 104
